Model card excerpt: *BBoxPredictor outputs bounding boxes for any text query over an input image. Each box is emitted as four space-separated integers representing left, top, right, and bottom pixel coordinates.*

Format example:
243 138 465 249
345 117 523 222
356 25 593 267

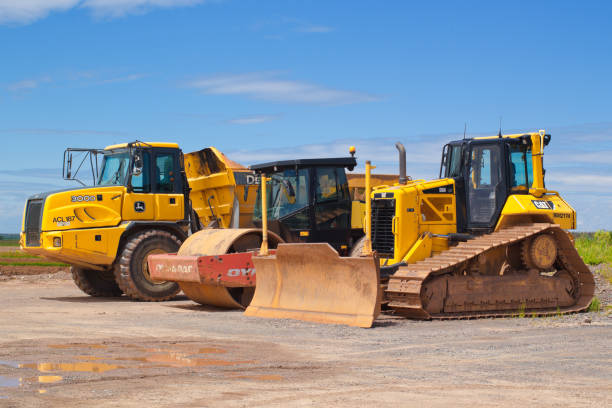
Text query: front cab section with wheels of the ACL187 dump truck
20 141 190 300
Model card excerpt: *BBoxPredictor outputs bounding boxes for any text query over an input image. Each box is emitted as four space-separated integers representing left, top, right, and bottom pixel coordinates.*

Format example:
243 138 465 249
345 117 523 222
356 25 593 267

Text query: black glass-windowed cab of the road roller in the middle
251 157 357 253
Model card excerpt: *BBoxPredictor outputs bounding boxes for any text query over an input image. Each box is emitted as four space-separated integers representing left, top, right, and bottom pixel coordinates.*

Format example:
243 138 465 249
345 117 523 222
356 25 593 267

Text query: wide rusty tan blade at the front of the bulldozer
245 243 380 327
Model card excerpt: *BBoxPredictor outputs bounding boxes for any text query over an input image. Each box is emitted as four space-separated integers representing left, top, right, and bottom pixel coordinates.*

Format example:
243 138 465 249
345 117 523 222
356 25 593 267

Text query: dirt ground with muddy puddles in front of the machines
0 273 612 407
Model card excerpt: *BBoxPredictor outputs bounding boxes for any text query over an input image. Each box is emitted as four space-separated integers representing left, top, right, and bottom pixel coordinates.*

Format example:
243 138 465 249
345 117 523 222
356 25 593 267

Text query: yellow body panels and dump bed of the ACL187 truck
20 143 258 271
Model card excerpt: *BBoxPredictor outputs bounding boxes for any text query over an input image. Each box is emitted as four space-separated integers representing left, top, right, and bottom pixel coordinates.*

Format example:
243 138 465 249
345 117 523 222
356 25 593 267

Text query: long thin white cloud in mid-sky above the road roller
187 73 379 104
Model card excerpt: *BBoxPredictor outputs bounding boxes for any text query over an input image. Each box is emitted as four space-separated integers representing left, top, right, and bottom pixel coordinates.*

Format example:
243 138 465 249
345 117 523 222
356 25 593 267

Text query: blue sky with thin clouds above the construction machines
0 0 612 232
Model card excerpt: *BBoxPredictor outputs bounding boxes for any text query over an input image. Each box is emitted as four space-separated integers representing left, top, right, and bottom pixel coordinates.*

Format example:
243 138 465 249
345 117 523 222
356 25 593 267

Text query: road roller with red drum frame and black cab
148 150 398 308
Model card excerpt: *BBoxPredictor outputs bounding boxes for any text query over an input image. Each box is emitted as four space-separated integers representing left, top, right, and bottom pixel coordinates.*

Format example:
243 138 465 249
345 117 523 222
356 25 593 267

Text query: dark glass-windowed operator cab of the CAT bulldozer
440 134 550 232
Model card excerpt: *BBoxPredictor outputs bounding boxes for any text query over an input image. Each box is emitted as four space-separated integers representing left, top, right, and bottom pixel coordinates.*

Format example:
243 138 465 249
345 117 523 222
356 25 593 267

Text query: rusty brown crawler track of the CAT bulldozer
386 223 595 319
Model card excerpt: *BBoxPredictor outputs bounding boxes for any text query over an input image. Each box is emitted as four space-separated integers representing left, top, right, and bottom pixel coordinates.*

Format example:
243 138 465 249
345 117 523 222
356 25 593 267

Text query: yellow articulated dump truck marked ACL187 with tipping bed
20 141 257 301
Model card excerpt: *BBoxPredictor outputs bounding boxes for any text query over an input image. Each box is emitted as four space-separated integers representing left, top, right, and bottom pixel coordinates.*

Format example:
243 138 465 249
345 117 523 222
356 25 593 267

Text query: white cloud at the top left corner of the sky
0 0 206 24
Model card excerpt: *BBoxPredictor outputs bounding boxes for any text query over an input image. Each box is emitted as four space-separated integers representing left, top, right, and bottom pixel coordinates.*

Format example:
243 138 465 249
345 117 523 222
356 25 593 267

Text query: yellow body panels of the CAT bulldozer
372 133 576 265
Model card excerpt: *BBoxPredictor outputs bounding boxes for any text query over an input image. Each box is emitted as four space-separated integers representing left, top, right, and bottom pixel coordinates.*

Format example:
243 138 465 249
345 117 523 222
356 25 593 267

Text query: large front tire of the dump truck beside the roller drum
115 230 181 302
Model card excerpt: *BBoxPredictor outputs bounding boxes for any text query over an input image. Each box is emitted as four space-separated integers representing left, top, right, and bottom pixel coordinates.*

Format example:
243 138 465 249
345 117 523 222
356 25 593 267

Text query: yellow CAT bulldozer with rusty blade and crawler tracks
245 131 594 327
